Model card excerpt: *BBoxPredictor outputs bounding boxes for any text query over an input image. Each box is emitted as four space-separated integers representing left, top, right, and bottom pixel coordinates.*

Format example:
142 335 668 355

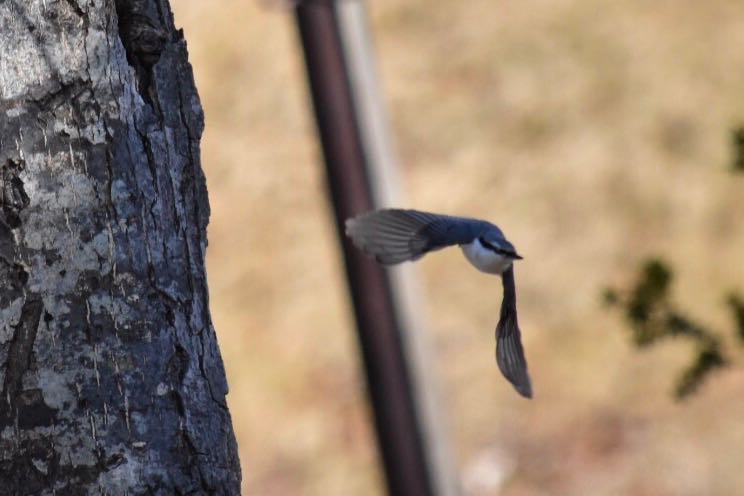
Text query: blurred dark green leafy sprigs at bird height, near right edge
603 258 744 399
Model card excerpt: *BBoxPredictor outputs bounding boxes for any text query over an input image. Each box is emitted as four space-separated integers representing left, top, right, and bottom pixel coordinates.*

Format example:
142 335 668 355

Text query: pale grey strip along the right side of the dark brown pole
336 0 461 496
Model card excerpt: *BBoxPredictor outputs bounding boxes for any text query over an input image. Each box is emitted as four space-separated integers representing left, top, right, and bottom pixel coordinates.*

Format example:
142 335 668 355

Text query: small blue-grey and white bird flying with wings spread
346 208 532 398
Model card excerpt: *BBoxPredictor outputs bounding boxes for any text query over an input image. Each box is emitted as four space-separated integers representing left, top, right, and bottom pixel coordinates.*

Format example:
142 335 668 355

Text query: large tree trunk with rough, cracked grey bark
0 0 240 495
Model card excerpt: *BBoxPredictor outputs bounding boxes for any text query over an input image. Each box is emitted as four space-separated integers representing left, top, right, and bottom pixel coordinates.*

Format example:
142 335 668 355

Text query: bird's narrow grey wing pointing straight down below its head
496 266 532 398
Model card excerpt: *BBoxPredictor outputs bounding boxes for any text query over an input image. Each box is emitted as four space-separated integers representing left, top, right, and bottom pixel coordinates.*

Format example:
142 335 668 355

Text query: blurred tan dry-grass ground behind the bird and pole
172 0 744 495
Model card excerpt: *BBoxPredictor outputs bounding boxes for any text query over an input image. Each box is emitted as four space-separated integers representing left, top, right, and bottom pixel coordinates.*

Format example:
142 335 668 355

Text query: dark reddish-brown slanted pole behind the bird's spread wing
296 0 434 496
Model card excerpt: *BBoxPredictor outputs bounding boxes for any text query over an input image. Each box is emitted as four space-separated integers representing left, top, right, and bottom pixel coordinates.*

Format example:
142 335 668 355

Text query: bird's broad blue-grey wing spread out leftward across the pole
346 209 483 265
